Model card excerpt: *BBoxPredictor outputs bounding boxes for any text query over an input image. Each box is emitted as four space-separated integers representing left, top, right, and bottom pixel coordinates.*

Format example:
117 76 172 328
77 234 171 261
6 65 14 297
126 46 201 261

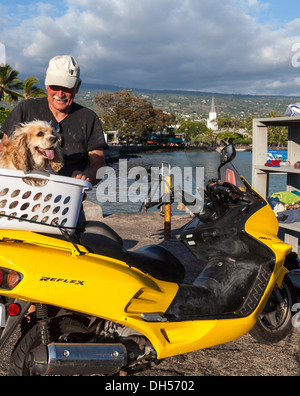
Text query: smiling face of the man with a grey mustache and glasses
46 82 80 113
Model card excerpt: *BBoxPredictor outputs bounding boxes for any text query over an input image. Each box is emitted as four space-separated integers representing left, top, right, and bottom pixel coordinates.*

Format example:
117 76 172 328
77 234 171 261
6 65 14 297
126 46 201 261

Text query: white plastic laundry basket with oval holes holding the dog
0 169 92 234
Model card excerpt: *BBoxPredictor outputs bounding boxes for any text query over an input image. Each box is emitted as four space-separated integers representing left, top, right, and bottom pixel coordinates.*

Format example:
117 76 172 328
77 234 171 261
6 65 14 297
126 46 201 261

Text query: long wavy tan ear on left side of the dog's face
10 133 31 172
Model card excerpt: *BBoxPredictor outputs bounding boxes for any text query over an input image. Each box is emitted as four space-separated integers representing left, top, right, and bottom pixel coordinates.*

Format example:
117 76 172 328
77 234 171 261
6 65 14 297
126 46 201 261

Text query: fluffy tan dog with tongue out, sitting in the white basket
0 120 63 172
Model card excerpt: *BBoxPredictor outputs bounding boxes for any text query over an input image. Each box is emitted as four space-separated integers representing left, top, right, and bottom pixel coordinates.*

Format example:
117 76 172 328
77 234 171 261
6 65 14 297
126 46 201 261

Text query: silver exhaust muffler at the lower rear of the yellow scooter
27 343 127 375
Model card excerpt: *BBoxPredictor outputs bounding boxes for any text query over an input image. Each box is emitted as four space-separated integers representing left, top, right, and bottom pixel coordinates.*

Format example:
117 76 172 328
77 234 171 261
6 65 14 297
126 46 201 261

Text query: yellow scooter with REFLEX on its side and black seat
0 145 291 376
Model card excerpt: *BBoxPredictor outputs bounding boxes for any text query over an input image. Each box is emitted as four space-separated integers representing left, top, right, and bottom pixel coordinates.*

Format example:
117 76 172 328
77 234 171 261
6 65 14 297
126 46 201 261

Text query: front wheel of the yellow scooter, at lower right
250 277 295 344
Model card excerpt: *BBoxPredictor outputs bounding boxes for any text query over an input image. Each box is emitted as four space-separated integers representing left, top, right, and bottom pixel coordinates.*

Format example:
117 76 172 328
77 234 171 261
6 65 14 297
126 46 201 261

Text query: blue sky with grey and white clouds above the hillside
0 0 300 96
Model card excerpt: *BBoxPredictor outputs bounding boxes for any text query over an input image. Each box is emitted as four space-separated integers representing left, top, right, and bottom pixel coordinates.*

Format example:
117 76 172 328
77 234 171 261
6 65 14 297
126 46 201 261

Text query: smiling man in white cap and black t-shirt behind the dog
1 55 107 185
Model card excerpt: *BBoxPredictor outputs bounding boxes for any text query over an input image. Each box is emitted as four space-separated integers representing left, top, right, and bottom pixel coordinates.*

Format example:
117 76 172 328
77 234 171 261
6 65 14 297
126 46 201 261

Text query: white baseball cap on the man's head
45 55 80 88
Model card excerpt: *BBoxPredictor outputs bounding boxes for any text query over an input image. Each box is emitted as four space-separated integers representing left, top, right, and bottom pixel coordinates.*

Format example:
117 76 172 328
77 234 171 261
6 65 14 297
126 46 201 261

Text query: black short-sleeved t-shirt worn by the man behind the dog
1 97 107 176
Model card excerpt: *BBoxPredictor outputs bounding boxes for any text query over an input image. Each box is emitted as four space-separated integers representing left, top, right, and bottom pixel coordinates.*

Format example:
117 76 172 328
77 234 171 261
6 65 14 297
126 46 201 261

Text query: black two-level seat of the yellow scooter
79 232 185 283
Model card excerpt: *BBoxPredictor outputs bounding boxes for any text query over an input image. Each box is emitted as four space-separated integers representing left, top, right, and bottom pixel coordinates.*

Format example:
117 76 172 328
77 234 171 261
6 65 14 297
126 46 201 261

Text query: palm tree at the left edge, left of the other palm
0 65 23 104
